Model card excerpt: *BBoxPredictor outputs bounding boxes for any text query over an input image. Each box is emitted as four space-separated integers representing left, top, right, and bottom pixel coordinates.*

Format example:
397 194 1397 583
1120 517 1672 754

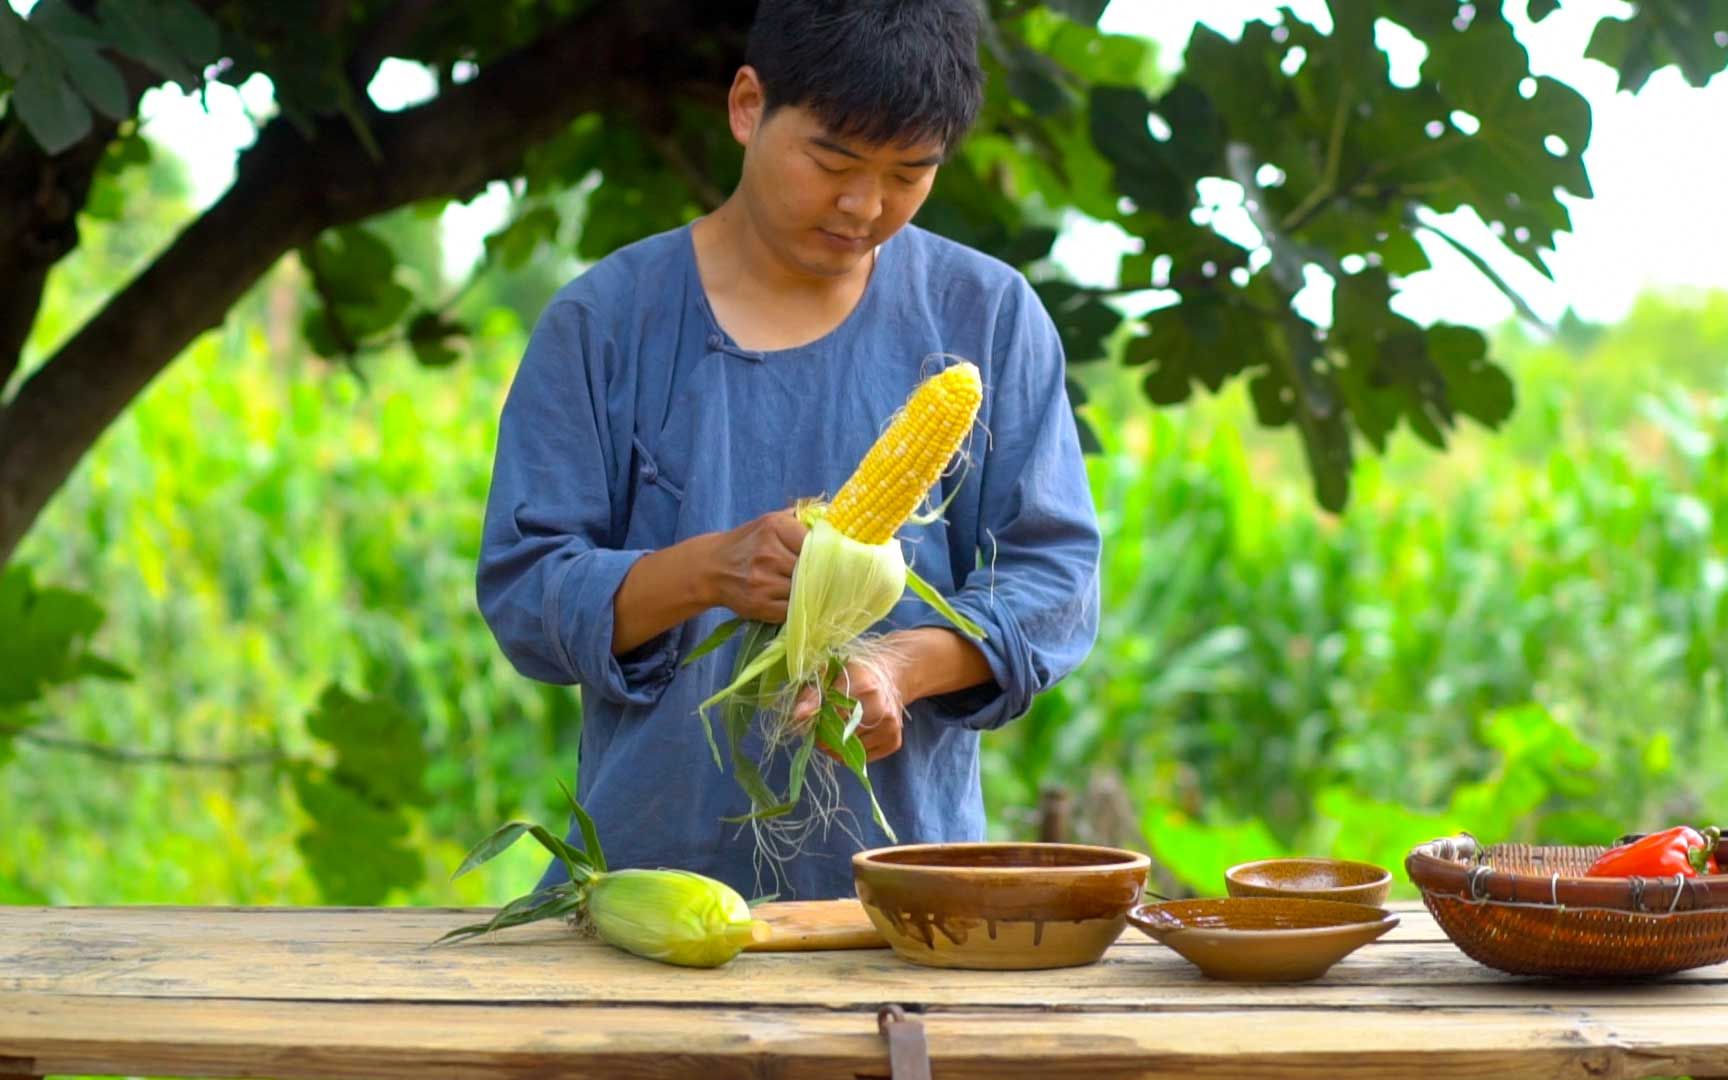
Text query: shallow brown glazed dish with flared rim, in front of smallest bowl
1128 897 1398 983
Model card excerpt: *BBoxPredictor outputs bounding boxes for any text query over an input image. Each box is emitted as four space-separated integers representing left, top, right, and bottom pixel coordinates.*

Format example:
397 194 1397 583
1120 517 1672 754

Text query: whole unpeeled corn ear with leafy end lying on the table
434 783 769 968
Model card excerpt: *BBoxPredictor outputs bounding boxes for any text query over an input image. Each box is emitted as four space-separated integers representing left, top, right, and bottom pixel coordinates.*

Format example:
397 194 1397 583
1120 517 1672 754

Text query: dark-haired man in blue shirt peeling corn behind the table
479 0 1099 899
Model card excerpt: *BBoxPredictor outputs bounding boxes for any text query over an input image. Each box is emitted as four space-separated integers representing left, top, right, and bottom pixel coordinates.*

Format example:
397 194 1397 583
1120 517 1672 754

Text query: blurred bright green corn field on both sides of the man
0 152 1728 904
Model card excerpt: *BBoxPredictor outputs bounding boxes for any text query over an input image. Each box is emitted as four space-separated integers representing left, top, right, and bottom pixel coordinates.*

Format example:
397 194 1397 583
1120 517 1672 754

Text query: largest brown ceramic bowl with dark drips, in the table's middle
852 843 1151 969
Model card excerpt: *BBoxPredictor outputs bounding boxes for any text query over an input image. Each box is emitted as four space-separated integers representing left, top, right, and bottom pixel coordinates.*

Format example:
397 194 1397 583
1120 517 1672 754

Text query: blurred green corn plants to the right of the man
985 314 1728 892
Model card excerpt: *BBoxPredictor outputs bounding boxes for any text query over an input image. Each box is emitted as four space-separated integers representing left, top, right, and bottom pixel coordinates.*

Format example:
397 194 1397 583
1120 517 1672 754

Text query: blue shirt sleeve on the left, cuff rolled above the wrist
475 299 677 705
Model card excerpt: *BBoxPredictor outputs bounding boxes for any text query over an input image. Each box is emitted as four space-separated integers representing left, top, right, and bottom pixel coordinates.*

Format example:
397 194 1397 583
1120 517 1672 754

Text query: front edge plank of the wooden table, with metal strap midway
0 995 1728 1080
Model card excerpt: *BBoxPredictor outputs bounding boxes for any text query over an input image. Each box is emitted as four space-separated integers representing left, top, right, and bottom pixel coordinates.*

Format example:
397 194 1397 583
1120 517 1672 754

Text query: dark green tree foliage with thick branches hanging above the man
0 0 1728 900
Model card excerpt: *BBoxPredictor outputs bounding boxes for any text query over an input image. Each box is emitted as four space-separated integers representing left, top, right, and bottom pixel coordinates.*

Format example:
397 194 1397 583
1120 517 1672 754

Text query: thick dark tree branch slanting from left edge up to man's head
0 0 750 565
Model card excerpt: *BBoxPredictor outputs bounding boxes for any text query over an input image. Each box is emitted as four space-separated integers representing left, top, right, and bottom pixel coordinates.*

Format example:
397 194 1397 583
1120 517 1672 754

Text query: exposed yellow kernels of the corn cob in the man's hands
828 363 983 544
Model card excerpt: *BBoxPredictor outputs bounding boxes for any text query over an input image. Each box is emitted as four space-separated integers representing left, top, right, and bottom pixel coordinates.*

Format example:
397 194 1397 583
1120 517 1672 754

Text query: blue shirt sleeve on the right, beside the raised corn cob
911 278 1099 731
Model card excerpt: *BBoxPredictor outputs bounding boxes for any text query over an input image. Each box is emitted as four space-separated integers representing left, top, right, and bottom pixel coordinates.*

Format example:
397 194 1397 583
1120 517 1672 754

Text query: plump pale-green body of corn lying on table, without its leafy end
588 869 769 968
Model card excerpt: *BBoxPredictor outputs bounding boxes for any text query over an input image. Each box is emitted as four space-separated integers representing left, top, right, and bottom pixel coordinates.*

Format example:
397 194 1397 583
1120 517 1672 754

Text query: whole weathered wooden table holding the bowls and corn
0 905 1728 1080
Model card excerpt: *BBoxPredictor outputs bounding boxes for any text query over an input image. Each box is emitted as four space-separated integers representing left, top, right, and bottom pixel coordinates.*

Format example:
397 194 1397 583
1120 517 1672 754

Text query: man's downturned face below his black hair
741 84 942 276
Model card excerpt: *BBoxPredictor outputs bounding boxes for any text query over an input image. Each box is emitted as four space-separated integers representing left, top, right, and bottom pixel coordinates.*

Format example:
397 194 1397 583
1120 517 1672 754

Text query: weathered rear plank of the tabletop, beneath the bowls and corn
0 909 1728 1011
